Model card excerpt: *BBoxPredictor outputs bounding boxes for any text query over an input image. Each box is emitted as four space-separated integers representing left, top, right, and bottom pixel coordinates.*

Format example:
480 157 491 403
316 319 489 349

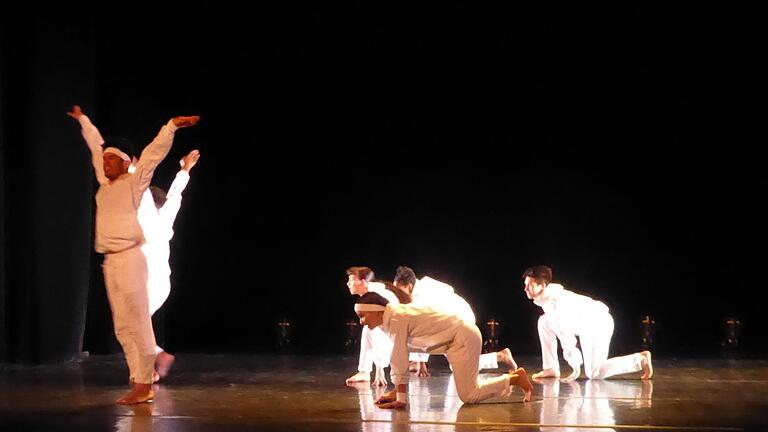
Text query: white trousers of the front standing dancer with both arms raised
102 247 155 384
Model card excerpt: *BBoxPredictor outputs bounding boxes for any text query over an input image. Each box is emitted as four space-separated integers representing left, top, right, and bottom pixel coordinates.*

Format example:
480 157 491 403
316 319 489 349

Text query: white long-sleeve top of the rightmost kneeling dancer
533 283 608 369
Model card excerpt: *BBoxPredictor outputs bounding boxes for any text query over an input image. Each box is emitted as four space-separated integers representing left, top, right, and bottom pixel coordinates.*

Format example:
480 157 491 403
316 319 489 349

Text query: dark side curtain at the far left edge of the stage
0 13 95 363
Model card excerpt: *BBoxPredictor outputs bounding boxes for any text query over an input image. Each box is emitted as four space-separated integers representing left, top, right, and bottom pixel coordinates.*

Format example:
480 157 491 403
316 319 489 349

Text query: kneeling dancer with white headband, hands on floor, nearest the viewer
355 292 533 408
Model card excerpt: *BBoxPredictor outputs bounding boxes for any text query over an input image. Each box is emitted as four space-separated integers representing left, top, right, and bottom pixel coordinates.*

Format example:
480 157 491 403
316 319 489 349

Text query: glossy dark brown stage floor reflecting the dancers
0 354 768 432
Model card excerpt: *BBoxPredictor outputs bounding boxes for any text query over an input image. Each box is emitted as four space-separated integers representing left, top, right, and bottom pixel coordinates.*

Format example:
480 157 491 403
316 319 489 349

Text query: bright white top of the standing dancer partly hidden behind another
138 170 189 275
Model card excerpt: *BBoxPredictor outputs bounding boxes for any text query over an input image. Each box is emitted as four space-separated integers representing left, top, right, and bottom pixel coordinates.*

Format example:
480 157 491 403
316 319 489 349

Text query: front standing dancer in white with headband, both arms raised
67 105 200 405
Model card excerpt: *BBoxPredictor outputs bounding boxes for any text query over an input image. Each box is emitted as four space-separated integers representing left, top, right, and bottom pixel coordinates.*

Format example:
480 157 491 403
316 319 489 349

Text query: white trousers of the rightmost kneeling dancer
538 313 643 379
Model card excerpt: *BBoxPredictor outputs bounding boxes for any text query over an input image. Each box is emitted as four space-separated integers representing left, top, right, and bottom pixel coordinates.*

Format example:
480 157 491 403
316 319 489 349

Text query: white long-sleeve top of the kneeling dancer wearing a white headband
381 304 466 385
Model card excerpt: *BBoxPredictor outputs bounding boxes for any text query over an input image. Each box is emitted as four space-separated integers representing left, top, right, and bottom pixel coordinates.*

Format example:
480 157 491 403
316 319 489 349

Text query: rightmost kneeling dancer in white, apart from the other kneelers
523 265 653 382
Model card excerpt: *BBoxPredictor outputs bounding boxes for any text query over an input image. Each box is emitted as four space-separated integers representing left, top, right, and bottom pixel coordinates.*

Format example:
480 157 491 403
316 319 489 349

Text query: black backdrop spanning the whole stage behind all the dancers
0 2 768 361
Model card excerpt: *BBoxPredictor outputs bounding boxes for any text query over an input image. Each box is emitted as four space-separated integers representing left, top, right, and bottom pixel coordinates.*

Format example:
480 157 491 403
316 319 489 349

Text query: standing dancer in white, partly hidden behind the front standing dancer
138 150 200 382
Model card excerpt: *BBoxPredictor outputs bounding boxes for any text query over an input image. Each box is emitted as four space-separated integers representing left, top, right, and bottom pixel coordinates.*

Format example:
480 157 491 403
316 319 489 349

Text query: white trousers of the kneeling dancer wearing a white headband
445 323 511 403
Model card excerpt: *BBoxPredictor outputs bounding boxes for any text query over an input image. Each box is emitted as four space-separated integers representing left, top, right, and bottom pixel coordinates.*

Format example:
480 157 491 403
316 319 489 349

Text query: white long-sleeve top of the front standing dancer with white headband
78 115 178 253
